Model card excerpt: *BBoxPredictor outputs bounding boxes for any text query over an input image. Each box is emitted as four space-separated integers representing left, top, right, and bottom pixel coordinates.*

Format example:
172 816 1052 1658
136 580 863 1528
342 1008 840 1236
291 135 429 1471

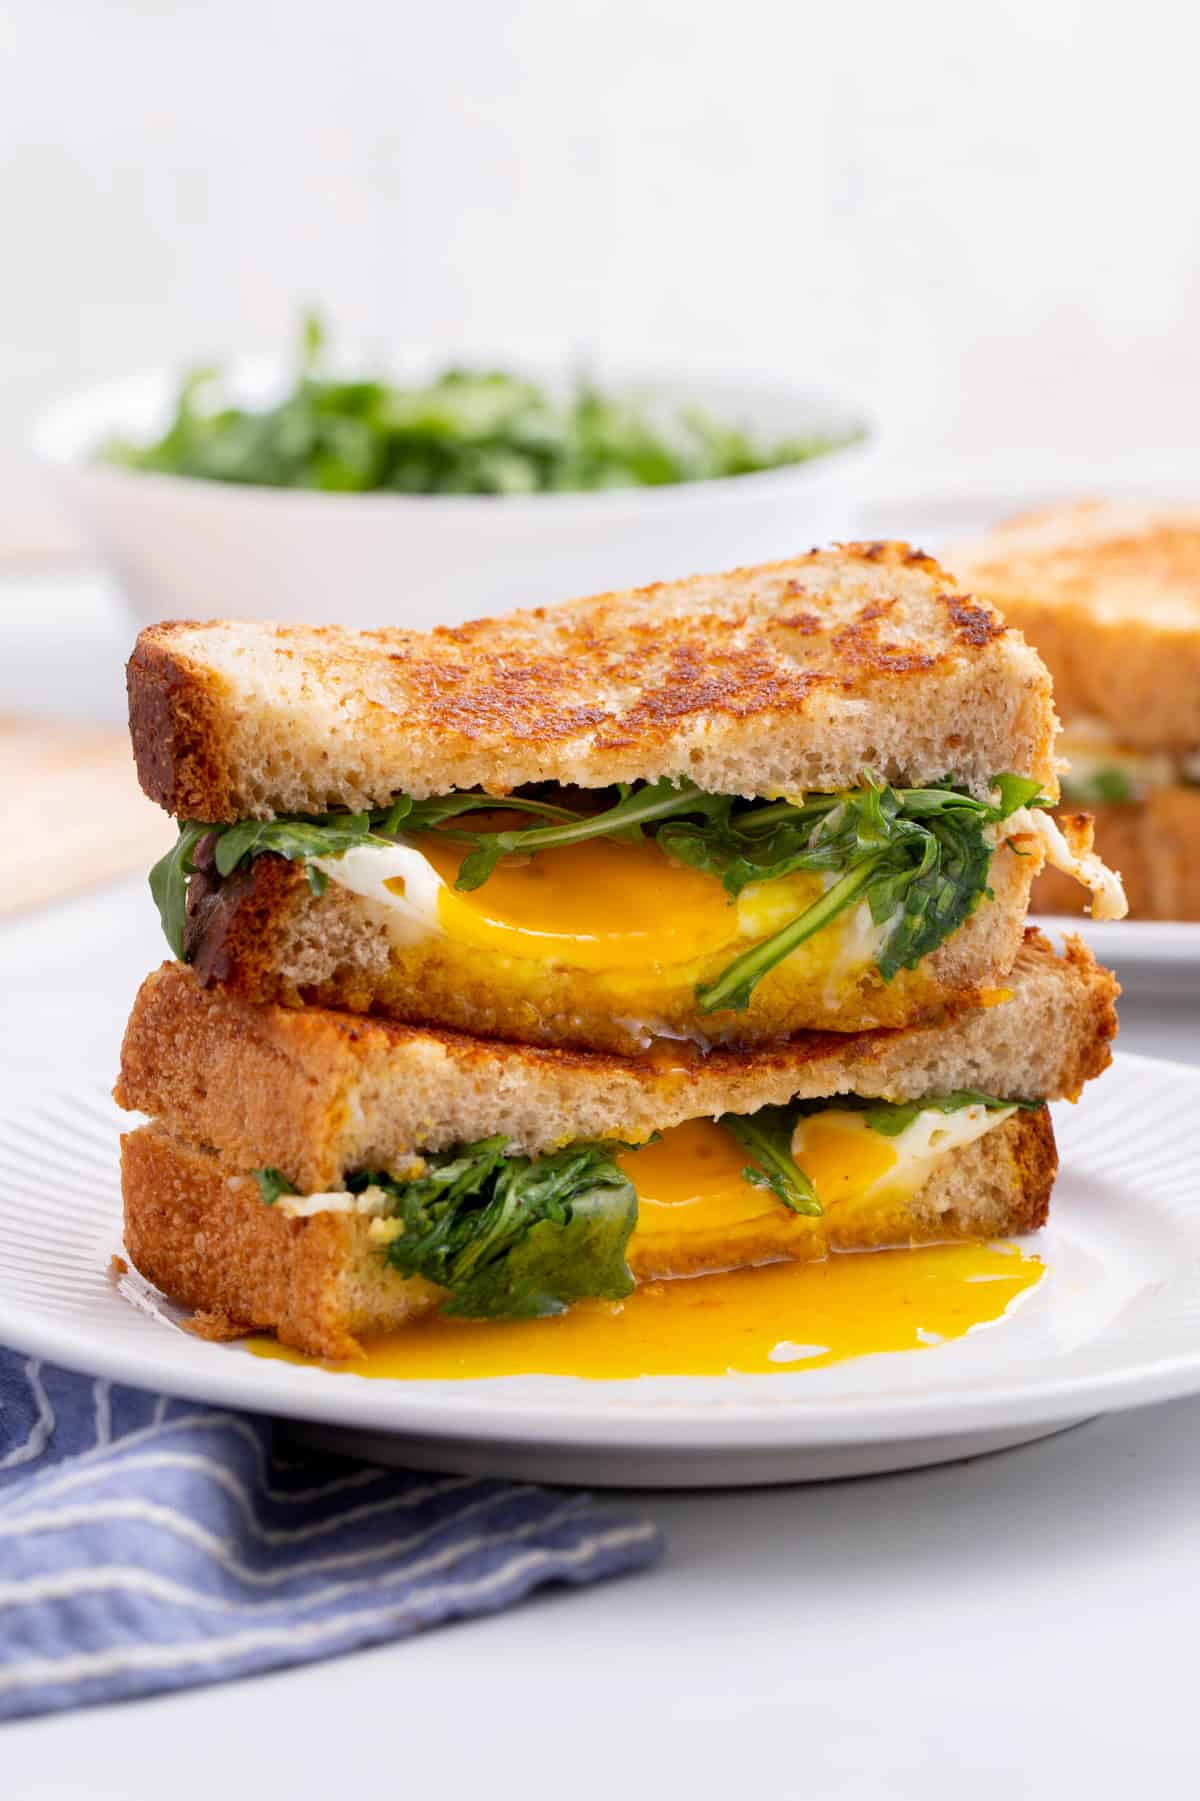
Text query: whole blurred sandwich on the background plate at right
953 502 1200 919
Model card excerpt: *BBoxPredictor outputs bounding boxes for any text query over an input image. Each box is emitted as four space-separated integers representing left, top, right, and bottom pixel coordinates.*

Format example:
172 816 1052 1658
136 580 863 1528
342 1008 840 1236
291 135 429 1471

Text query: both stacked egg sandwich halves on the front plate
117 544 1121 1358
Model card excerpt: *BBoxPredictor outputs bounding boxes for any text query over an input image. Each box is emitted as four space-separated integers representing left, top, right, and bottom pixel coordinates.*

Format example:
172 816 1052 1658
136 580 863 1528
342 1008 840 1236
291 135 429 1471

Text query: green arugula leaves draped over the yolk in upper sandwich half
151 773 1041 1012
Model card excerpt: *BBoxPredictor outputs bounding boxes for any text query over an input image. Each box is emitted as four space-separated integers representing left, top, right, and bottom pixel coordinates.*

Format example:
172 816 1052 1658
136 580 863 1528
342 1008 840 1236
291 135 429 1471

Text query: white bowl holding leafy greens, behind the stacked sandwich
34 351 872 627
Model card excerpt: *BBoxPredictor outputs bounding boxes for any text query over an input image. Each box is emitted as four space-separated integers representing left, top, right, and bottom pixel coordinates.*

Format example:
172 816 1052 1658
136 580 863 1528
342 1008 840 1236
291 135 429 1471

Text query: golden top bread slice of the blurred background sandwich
948 501 1200 751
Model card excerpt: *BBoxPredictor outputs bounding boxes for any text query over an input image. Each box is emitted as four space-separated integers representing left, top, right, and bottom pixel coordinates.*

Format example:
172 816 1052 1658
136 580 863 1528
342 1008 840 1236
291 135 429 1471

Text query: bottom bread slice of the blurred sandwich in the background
1032 787 1200 919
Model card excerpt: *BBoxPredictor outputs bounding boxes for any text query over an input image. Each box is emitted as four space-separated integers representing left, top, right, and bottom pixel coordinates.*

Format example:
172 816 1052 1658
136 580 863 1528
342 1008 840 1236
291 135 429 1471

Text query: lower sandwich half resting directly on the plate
115 935 1117 1358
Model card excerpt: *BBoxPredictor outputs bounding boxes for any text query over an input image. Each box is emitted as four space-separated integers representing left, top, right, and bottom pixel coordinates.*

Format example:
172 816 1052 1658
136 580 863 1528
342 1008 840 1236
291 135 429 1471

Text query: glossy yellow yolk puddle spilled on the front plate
249 1244 1045 1380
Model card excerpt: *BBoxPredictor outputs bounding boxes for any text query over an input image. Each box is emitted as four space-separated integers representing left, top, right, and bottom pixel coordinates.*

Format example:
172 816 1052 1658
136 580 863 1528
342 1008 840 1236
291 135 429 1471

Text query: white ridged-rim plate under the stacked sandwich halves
0 1057 1200 1486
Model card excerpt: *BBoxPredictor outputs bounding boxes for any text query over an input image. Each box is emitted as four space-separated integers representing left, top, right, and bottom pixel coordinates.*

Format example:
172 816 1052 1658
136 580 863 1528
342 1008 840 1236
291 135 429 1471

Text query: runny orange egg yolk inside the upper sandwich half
401 832 822 969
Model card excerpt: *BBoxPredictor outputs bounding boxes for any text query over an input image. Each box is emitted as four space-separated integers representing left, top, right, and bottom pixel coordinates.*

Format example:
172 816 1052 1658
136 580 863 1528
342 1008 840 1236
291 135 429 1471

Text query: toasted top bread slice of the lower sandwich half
115 933 1117 1194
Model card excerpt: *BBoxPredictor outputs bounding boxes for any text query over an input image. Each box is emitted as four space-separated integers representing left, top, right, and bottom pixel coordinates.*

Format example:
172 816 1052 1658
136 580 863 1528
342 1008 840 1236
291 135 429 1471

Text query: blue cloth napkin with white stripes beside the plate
0 1349 661 1720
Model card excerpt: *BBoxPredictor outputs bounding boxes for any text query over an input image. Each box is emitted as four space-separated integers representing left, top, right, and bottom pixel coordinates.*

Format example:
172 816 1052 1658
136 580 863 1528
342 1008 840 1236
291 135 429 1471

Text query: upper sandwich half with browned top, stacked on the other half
128 544 1123 1052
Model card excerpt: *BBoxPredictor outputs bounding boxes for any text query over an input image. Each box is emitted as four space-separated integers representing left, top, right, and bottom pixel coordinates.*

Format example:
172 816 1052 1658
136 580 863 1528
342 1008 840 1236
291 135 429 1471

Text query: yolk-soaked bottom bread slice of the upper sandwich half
175 843 1041 1052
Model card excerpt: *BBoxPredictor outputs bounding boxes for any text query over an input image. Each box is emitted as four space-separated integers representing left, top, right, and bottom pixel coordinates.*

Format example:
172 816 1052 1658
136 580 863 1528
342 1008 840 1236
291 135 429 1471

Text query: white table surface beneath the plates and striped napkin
0 879 1200 1801
